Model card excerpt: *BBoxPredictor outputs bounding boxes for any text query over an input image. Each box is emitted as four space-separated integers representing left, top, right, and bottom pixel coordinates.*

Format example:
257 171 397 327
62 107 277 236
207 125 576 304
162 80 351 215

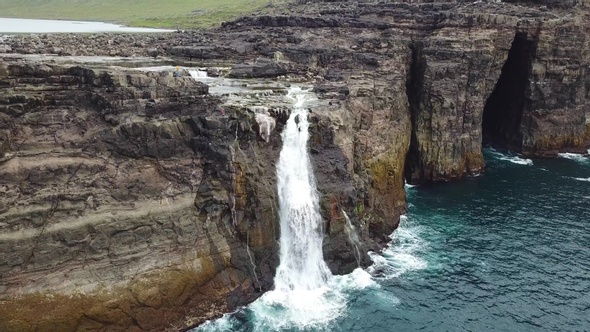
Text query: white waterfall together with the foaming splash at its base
195 87 374 332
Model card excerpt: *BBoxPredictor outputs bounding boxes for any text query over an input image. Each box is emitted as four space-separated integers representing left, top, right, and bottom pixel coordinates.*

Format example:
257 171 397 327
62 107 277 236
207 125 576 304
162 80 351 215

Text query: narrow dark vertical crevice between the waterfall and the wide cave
404 42 426 183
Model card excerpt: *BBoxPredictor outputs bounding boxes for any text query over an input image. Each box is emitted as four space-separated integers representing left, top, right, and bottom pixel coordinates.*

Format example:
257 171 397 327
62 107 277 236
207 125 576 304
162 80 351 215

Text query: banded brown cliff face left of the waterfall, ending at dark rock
0 61 254 331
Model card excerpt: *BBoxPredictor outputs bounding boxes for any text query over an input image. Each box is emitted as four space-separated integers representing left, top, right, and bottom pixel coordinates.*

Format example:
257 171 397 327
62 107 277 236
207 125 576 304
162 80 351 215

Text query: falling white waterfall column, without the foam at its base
275 88 331 291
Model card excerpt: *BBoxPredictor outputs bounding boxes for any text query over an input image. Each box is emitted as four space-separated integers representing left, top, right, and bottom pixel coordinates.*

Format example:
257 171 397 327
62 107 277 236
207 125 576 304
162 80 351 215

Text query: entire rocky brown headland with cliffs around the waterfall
0 1 590 331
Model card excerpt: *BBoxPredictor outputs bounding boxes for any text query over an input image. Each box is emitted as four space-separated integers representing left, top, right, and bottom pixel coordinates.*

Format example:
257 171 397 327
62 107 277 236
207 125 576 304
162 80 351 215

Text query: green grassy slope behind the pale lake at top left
0 0 287 28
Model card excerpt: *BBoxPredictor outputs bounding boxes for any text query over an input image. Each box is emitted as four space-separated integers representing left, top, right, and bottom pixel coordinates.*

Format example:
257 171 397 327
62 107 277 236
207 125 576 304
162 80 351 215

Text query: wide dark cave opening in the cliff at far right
482 32 537 150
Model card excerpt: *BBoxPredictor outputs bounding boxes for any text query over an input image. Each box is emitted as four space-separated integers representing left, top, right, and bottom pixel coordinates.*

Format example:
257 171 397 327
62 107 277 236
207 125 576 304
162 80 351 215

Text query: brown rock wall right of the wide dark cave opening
521 16 590 155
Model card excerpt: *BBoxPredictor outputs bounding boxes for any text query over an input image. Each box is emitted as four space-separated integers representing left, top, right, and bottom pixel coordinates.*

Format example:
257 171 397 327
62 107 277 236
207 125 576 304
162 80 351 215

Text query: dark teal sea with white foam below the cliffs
195 150 590 331
